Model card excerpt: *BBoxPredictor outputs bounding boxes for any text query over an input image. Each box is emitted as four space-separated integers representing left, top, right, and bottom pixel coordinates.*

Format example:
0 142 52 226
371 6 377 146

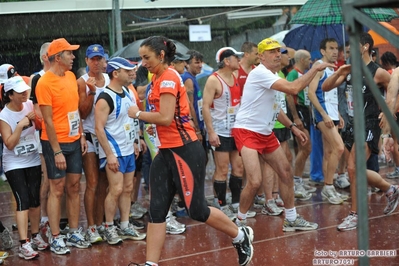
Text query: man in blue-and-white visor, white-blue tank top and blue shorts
94 57 146 245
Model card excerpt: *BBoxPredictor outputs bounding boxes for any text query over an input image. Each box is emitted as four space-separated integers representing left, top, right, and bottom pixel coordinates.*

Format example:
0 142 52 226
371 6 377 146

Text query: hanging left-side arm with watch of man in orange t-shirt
40 105 66 170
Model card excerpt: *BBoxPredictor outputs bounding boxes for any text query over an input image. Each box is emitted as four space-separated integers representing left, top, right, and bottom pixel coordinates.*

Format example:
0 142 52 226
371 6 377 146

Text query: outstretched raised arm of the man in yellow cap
272 63 334 94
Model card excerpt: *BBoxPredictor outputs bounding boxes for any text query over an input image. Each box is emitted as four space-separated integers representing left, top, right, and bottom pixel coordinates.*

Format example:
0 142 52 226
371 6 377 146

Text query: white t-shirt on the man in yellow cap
234 64 281 135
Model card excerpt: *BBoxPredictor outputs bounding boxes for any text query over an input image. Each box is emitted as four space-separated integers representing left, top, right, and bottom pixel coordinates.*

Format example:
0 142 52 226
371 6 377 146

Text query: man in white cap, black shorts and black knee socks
202 47 250 219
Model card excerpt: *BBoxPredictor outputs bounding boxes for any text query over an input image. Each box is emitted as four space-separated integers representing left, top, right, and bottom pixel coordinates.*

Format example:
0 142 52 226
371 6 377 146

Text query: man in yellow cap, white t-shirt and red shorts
233 39 333 231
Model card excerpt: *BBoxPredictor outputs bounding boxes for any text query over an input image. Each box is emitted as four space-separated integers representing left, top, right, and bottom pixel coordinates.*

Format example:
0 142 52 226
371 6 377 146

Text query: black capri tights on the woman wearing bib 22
5 165 42 211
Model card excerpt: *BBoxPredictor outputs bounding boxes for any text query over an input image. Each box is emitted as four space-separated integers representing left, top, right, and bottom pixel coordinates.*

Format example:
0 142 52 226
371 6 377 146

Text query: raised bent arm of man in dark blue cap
77 77 96 119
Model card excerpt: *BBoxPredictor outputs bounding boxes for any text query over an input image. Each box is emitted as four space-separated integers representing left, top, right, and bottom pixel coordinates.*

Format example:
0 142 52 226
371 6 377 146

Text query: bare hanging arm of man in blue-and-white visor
94 99 119 173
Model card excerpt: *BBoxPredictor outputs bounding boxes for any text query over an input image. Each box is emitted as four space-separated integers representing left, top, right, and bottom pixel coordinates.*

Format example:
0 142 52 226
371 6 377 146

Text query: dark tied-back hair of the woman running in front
140 36 176 65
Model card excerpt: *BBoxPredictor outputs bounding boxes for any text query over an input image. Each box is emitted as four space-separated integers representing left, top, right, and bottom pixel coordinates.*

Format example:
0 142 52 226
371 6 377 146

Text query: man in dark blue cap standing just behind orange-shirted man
78 44 109 243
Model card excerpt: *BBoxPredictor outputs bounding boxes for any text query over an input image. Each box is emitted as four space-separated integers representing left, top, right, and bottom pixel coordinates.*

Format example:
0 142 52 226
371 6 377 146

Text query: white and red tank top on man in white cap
211 72 241 137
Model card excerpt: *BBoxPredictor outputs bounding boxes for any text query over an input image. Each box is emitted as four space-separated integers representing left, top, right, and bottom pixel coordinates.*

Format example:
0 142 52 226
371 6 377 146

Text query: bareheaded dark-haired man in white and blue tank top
309 38 348 204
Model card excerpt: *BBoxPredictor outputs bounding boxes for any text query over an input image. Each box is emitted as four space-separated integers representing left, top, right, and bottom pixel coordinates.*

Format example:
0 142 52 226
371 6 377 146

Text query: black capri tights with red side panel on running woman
150 141 210 223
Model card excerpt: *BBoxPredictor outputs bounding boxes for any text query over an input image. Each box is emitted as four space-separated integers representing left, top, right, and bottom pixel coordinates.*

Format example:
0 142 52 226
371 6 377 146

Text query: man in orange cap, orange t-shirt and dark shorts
36 38 91 254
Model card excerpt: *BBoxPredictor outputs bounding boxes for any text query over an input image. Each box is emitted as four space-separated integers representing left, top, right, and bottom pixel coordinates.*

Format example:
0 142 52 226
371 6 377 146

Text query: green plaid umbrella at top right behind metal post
290 0 399 26
